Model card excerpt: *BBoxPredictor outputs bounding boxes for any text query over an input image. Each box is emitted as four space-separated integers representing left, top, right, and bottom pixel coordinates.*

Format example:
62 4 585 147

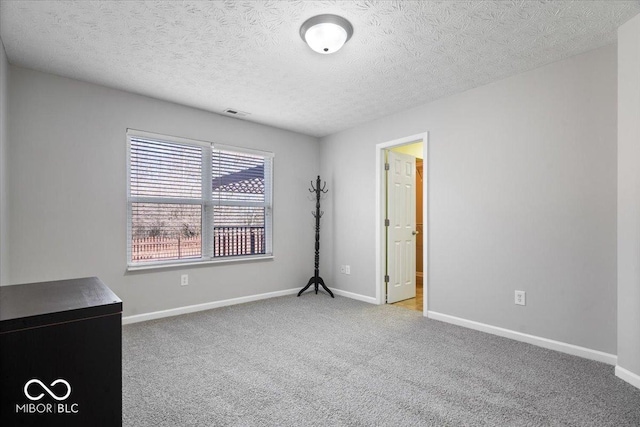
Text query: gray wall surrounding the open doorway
320 46 617 354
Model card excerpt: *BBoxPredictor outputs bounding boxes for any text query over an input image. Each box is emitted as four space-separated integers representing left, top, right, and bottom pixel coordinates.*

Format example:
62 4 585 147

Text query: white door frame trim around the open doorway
375 132 429 317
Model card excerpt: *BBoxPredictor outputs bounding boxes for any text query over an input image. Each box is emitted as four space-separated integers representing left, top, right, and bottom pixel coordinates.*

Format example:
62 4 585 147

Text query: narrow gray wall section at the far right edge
618 15 640 376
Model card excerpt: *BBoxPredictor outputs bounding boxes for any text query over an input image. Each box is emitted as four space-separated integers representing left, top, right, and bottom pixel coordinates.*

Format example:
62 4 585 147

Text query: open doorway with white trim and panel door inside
376 133 428 315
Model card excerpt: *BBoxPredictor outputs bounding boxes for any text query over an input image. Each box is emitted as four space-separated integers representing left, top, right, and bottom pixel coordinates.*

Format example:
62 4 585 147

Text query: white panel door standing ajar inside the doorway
387 151 416 303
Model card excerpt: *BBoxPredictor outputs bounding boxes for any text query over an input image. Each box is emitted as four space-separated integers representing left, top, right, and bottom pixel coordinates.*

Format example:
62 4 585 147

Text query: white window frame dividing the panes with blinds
127 129 274 271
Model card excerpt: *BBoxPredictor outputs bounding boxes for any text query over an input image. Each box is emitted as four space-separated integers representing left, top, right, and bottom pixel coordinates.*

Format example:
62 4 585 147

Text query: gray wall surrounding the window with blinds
8 67 319 315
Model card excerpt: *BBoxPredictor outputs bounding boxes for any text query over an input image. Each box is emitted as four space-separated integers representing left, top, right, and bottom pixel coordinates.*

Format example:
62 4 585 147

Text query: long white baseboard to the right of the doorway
427 311 618 365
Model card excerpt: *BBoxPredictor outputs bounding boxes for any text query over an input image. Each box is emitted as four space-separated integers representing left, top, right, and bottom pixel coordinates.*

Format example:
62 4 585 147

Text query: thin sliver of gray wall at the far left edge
0 39 9 286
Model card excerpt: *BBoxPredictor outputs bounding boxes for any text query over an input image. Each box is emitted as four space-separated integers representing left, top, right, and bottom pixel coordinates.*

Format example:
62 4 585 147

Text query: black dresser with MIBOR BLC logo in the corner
0 277 122 426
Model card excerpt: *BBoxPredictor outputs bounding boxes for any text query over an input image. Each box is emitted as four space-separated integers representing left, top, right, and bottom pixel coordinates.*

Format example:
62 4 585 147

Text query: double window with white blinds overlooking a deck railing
127 130 273 267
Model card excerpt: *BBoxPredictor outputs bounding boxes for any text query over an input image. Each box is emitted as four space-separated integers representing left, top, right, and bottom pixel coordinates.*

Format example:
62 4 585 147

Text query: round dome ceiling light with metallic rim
300 15 353 55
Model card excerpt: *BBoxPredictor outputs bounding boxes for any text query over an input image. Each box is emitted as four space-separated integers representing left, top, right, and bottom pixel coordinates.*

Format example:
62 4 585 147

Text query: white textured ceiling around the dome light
0 0 640 136
